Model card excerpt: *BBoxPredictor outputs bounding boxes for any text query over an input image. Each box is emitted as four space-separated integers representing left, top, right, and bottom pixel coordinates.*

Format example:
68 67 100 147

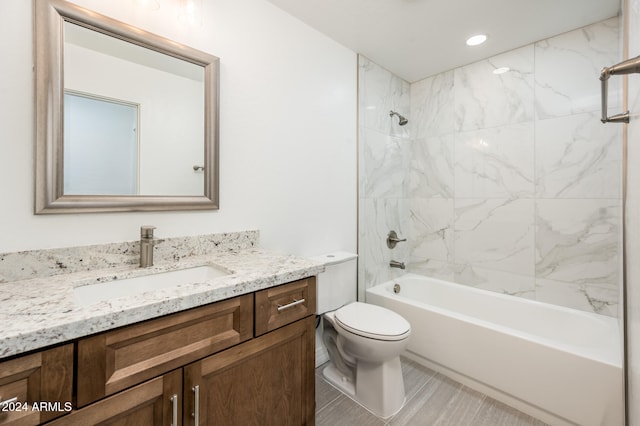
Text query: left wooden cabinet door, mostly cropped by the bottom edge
49 370 182 426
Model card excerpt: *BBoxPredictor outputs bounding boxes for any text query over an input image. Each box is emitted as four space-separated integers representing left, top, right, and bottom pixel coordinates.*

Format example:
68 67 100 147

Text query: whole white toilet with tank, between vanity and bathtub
315 252 411 418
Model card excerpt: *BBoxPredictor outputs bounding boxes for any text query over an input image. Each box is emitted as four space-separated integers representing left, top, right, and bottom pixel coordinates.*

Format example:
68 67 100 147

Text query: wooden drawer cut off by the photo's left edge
0 344 73 425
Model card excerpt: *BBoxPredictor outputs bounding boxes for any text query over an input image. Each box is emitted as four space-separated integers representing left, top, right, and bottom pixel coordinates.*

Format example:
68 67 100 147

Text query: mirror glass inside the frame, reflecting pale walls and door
64 22 204 195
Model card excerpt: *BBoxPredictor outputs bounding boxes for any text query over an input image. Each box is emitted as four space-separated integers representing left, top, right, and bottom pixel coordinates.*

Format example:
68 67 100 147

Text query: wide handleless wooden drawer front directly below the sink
77 294 253 407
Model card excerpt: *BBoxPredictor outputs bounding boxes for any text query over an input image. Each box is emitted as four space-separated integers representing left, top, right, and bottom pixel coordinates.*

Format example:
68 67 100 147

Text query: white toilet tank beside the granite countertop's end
312 251 358 315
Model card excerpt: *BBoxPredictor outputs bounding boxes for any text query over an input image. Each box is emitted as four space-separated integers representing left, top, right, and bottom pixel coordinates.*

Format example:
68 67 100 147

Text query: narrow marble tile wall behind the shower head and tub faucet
358 56 413 300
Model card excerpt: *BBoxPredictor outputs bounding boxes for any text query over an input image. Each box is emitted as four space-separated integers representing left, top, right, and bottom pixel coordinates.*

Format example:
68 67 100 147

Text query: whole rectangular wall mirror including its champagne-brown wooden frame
36 0 218 214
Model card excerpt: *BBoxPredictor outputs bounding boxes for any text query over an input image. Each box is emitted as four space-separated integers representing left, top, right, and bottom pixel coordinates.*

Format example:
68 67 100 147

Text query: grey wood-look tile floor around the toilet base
316 358 546 426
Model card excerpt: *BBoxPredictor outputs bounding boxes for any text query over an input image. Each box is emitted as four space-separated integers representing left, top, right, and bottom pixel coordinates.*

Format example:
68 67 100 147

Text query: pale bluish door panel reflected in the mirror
64 92 138 195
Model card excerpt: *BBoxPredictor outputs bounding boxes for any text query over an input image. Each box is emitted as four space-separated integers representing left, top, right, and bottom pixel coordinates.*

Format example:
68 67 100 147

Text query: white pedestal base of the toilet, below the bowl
322 357 405 419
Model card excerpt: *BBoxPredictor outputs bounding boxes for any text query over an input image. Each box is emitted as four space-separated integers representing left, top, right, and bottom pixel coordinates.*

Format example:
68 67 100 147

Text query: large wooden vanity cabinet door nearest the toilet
184 316 315 426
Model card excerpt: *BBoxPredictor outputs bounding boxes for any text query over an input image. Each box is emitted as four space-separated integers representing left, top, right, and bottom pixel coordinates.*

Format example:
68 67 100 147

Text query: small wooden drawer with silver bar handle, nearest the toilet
255 277 316 336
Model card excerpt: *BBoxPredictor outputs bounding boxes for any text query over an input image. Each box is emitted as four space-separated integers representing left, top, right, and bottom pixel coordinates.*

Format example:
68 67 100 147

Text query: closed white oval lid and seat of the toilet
334 302 411 340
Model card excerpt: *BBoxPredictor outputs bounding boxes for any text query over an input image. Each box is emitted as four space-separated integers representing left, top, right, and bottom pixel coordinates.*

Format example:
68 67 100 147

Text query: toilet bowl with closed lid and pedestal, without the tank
323 302 411 418
